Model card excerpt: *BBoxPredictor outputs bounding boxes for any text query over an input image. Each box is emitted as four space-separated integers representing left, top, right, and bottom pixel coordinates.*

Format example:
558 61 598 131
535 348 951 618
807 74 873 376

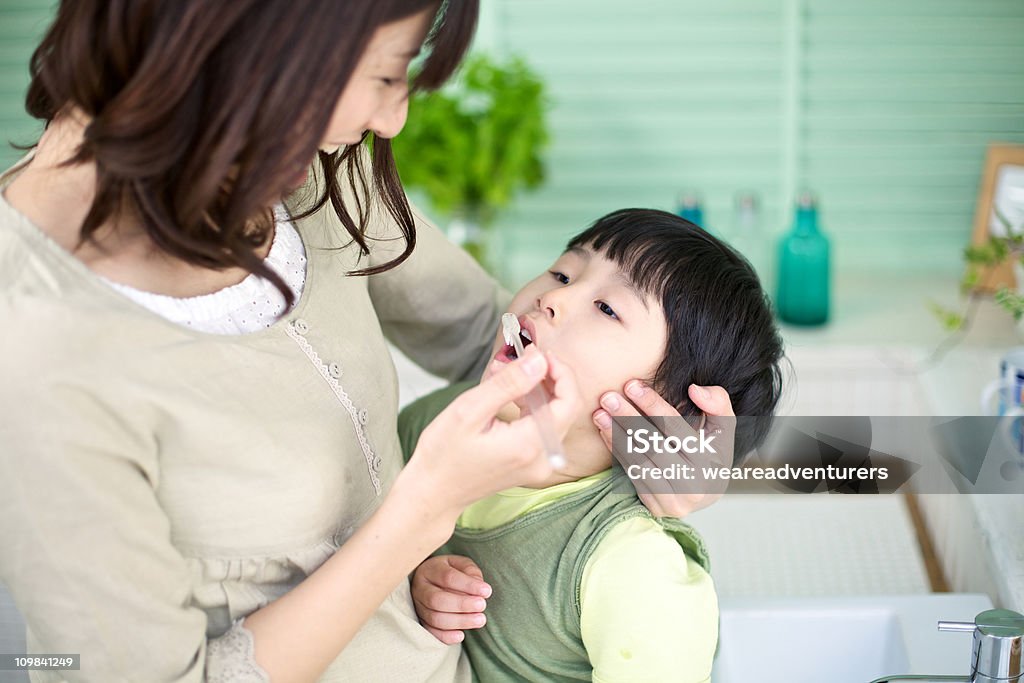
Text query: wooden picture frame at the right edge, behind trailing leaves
971 142 1024 292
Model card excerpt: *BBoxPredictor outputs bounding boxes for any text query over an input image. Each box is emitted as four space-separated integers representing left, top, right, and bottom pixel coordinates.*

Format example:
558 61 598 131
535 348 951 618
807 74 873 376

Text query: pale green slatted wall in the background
0 0 1024 284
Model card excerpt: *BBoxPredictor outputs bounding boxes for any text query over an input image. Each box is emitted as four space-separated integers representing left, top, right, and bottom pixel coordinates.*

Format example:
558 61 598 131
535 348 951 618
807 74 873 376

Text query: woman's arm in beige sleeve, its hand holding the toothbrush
0 352 580 683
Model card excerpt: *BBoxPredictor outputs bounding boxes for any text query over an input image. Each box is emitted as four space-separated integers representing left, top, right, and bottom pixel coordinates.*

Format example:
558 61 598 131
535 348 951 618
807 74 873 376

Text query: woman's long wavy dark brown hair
26 0 478 306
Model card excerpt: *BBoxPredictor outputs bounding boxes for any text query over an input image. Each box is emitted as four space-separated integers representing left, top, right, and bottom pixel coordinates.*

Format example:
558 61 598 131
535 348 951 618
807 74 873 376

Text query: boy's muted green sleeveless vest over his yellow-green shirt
398 384 710 683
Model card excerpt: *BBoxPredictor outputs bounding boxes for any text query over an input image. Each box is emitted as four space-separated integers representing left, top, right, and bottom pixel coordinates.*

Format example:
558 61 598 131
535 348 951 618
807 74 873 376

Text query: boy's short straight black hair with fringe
566 209 782 456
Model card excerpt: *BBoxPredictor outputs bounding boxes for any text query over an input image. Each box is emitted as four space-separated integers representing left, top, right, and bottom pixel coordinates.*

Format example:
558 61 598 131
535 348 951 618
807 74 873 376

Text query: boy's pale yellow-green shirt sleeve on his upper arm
580 517 718 683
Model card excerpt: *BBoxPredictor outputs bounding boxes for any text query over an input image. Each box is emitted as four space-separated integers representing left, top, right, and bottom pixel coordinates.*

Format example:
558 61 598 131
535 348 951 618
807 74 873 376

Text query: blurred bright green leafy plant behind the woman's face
392 54 548 266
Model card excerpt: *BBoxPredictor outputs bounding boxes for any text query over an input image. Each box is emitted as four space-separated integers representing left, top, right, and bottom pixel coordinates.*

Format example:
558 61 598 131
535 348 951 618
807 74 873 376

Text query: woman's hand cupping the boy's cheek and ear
593 380 736 517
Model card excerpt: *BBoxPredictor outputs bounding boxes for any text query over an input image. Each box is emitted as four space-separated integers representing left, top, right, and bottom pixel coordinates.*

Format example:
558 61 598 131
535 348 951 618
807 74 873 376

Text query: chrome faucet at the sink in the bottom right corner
871 609 1024 683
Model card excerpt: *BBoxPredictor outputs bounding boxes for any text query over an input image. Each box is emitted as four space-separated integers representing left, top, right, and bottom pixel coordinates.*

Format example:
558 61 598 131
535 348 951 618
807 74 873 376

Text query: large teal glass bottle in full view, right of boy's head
775 193 829 325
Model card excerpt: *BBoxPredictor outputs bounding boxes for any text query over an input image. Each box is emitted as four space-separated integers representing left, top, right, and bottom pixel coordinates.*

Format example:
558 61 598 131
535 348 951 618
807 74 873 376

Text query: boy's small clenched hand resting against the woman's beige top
412 555 490 645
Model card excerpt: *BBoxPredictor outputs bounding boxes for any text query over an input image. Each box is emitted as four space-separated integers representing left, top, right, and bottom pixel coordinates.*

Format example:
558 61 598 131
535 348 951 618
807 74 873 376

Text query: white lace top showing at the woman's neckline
105 207 306 335
